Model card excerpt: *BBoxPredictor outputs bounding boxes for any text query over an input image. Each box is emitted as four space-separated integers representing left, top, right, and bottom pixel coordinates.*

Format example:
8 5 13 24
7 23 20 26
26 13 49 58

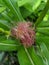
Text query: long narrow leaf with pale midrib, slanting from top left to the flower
3 0 23 21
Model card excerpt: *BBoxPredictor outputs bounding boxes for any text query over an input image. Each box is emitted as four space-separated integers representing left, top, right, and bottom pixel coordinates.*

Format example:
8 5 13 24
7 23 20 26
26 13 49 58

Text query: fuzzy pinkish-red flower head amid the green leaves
11 22 35 47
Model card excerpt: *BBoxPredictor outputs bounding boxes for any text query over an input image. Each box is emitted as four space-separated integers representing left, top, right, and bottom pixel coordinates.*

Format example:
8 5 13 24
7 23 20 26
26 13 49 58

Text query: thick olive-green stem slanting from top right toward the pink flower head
35 0 49 26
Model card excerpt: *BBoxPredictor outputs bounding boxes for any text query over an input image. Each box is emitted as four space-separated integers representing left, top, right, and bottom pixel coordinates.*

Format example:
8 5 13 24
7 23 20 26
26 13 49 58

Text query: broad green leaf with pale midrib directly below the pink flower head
17 47 44 65
